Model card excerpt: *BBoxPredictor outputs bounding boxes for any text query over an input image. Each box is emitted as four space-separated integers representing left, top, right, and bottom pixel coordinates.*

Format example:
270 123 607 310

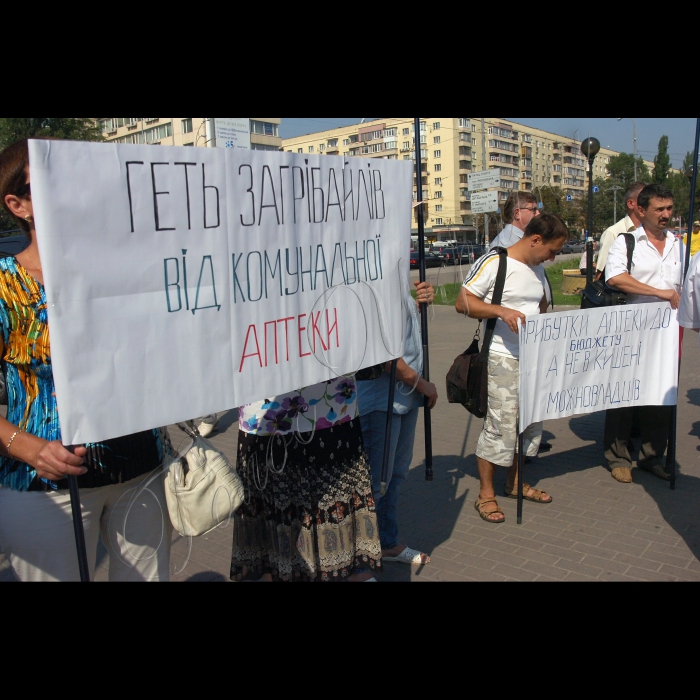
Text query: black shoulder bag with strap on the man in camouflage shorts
446 248 508 418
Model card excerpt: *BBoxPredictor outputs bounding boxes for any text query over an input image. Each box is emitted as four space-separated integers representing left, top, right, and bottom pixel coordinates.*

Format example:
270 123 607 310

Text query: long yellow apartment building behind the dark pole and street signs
283 117 653 241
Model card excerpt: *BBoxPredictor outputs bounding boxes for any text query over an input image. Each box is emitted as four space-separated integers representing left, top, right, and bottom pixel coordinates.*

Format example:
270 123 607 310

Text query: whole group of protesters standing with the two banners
0 135 700 582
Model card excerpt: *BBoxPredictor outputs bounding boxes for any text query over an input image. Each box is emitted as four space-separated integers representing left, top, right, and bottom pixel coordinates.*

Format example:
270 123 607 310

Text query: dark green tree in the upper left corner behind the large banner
0 117 102 231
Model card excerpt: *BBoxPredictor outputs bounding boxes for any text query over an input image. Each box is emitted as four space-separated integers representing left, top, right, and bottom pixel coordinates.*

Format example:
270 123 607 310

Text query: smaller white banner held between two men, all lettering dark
520 302 679 432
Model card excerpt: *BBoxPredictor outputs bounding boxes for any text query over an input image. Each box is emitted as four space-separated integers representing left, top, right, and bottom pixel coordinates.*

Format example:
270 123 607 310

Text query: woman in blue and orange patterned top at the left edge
0 140 170 581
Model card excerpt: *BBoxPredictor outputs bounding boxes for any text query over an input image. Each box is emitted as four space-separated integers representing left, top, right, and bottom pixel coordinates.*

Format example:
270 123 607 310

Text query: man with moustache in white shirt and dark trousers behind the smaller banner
603 185 684 483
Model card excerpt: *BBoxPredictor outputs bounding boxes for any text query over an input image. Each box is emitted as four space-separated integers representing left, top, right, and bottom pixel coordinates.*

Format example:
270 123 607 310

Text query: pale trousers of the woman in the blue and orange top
0 474 172 581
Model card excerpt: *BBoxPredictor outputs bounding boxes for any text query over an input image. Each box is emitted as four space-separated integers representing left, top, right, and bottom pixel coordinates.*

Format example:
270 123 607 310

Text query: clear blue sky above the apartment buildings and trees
280 117 695 168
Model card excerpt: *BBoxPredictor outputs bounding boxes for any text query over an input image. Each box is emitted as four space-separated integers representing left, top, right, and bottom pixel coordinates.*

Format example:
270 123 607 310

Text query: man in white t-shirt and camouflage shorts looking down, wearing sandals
456 214 569 523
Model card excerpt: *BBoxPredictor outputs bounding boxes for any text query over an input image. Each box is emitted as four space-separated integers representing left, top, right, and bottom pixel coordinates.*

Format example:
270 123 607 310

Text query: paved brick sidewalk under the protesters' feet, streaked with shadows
0 307 700 581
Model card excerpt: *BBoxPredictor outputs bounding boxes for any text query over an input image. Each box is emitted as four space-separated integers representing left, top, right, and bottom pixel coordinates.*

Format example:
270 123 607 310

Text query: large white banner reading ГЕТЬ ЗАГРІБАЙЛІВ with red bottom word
30 141 412 444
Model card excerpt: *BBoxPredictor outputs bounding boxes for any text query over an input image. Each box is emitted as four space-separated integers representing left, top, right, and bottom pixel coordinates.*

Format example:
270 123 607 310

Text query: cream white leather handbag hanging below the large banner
165 422 244 537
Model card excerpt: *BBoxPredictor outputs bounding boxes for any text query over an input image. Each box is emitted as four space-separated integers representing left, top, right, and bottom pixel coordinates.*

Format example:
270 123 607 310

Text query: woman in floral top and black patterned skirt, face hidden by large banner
231 377 381 581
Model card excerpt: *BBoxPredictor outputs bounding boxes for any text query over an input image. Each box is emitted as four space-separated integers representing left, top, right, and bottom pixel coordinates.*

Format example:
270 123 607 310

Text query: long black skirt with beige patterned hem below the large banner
231 419 381 581
